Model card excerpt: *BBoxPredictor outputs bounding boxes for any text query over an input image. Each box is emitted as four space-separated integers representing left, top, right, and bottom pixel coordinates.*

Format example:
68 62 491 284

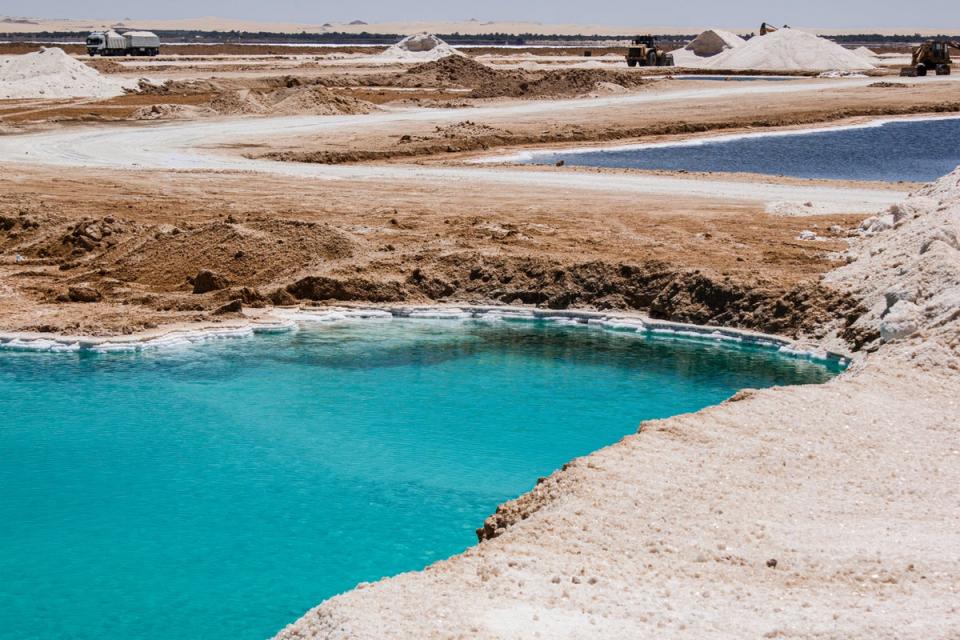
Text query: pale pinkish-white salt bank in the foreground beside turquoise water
277 169 960 640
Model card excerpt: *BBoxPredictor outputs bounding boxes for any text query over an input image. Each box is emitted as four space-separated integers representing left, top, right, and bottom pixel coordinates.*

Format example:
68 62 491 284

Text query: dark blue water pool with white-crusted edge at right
528 118 960 182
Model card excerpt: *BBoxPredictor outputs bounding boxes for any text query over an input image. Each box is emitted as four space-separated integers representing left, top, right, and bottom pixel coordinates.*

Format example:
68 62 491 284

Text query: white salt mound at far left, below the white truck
0 47 131 99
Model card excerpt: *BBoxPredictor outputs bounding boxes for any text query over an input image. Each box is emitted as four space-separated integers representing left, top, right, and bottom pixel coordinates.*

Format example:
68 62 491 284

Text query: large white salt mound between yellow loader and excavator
707 29 874 71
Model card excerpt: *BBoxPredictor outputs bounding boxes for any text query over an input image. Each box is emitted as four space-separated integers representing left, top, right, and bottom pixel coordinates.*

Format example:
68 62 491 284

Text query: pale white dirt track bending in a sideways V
0 78 916 214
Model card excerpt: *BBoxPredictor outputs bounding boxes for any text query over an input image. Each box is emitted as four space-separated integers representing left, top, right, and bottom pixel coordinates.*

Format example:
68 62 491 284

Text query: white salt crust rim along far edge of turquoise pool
0 305 850 366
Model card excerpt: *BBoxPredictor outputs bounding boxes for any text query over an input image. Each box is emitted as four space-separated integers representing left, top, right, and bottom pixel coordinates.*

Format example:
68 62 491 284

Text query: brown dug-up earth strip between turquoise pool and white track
0 167 861 342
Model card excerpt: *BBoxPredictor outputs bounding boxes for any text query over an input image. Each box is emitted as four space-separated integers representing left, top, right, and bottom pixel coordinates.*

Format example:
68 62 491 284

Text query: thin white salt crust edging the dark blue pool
478 115 960 164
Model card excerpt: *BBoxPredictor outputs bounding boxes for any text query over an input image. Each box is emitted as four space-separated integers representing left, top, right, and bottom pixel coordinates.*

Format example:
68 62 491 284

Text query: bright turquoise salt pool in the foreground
0 319 837 640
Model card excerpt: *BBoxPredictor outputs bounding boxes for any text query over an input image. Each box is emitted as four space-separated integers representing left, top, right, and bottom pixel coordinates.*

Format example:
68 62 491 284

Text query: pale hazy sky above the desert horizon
0 0 960 29
